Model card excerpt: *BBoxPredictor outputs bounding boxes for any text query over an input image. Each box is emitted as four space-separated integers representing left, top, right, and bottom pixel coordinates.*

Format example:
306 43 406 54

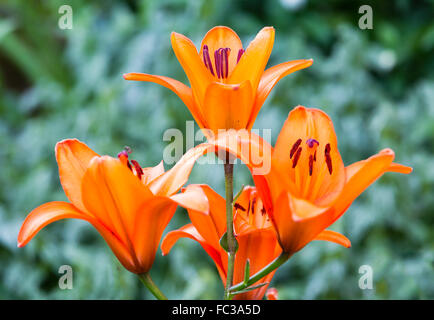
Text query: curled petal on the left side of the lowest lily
161 224 226 281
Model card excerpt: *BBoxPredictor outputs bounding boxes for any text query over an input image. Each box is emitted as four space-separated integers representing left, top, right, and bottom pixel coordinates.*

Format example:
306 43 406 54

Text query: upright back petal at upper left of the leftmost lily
55 139 98 211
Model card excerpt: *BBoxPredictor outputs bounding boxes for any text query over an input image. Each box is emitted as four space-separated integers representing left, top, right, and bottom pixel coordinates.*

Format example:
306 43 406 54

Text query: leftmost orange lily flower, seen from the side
18 139 211 274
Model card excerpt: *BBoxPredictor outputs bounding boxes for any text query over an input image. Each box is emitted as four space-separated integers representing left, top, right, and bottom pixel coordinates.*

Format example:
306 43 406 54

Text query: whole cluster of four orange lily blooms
18 27 412 300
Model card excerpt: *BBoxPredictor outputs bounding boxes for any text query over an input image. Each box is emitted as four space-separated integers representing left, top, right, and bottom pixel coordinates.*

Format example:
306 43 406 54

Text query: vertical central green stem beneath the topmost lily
224 162 236 300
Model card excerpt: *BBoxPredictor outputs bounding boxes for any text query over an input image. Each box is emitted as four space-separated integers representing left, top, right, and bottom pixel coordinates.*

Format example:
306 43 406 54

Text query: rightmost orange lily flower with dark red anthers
209 106 412 255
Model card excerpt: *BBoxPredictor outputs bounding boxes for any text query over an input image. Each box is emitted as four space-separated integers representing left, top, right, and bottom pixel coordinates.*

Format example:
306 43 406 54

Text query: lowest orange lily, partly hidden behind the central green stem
161 185 281 300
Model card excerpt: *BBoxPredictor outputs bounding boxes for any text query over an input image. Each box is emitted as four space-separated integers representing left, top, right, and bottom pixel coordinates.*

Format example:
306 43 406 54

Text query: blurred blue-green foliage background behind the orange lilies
0 0 434 299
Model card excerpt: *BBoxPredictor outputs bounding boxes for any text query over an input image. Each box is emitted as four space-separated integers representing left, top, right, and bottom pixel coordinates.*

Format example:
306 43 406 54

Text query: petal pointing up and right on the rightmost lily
334 149 402 219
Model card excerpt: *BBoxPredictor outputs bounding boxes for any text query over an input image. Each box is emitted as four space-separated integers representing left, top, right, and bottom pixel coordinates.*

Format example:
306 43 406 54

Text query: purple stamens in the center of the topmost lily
202 44 244 79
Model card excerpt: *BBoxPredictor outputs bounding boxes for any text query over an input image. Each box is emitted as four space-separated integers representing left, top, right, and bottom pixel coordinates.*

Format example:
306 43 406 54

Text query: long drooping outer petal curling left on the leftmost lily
18 201 135 272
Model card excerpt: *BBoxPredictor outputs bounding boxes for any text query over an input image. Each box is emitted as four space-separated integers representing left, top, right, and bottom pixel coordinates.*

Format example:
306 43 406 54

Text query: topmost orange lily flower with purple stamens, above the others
124 26 313 134
